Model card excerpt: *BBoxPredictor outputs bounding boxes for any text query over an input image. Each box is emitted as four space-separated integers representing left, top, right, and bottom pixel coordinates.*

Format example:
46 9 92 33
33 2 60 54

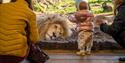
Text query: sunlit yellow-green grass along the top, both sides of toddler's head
34 0 111 14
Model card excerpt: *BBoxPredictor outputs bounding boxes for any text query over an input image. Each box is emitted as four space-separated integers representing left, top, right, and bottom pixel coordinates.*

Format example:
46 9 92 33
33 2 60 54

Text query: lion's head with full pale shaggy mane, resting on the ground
37 14 70 40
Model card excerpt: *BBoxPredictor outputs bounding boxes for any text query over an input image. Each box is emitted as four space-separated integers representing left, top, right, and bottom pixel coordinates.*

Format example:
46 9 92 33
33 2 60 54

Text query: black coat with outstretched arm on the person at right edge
100 4 125 48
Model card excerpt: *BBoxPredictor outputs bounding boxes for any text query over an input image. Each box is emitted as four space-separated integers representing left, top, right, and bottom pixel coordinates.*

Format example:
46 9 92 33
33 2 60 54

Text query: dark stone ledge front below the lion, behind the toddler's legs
39 41 123 50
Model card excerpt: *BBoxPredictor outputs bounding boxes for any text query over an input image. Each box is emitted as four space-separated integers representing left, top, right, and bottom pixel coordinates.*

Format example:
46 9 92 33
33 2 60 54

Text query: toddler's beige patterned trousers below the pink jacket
77 31 93 52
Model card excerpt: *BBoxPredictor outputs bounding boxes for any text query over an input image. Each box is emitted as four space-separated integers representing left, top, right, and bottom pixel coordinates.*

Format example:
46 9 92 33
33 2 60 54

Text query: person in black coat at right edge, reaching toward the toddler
99 0 125 62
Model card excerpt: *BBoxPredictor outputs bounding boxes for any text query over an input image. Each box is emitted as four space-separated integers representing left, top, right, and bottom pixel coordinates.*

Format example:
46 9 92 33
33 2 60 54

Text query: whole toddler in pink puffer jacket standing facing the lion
69 0 93 55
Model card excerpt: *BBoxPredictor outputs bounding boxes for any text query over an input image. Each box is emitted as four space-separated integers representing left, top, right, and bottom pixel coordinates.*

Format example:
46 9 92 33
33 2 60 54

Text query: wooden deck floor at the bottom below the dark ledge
45 50 125 63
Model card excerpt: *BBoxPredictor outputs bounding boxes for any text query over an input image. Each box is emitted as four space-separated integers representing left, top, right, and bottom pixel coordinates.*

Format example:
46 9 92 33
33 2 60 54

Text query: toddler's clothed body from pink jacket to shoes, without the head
75 10 93 55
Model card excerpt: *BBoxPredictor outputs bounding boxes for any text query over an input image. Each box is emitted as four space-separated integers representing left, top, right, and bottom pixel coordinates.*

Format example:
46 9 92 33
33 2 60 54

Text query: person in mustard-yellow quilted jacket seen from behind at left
0 0 39 63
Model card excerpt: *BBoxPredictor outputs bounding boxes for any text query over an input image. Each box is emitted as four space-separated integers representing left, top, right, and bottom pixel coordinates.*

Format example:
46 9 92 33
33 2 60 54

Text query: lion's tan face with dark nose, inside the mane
45 24 64 40
